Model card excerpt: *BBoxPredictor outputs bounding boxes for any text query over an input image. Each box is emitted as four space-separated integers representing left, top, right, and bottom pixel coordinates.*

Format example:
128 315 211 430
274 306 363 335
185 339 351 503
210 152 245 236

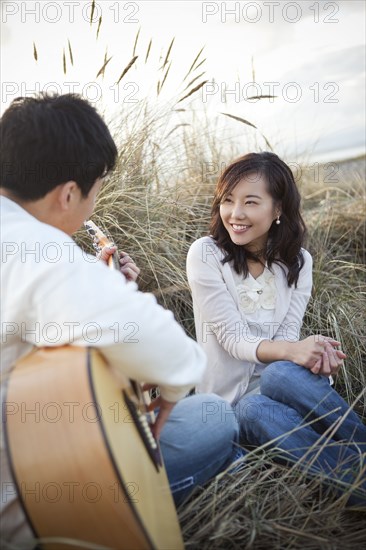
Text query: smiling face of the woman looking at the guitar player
220 174 281 252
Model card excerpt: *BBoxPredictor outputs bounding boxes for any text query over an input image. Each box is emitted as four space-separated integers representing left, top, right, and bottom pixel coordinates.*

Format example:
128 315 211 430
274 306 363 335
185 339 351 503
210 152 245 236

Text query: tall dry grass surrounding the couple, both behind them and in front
75 112 366 550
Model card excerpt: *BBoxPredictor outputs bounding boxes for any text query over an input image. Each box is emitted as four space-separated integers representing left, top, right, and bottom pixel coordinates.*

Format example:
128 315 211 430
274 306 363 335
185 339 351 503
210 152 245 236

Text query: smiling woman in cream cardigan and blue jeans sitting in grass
187 152 366 503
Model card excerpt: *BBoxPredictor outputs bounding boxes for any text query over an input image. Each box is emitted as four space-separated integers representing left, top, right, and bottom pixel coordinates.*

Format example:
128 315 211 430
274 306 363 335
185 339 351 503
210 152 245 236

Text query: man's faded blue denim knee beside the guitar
160 394 243 505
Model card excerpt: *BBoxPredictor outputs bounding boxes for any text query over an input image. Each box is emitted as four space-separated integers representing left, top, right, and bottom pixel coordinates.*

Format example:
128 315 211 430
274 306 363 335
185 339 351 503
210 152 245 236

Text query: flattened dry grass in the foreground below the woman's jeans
180 462 366 550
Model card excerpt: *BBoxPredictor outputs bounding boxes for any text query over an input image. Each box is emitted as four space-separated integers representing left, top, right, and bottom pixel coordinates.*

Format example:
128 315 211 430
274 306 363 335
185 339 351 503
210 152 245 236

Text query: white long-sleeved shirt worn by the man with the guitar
0 196 206 548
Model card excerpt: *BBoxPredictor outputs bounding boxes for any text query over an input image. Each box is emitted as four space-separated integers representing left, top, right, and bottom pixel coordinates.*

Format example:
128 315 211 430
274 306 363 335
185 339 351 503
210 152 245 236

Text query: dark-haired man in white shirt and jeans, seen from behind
0 94 242 543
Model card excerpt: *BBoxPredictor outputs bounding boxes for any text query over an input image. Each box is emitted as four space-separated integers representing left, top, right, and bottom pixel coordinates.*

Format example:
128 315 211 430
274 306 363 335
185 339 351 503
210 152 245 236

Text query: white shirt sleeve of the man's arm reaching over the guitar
34 252 206 401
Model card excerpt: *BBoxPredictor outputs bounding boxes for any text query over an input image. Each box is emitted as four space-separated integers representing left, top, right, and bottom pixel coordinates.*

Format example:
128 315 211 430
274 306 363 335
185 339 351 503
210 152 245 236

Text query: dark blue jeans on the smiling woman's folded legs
234 361 366 505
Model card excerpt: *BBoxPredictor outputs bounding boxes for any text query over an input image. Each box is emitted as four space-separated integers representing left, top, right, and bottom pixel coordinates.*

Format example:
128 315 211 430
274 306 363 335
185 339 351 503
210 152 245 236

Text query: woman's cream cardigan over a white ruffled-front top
187 237 312 404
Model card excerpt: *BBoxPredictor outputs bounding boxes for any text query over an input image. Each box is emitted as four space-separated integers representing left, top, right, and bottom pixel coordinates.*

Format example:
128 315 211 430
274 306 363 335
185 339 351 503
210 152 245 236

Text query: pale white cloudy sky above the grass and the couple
1 0 366 160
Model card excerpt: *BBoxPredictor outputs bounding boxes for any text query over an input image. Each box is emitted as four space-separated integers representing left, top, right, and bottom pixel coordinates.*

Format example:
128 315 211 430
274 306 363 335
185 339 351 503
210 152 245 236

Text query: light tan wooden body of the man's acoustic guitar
5 346 183 550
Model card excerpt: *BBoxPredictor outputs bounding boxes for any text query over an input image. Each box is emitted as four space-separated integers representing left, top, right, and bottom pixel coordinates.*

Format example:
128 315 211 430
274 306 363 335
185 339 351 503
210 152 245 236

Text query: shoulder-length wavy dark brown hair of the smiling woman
210 152 306 286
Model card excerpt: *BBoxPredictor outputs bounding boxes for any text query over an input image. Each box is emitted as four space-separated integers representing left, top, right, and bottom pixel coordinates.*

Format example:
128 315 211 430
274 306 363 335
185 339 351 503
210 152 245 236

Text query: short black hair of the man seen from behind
0 94 117 201
